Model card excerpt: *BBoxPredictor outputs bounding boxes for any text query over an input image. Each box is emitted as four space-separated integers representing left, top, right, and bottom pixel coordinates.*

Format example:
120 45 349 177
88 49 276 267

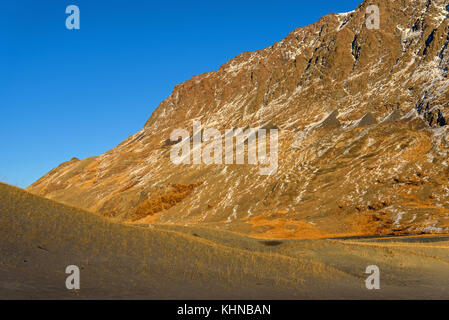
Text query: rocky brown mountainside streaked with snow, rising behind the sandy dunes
29 0 449 237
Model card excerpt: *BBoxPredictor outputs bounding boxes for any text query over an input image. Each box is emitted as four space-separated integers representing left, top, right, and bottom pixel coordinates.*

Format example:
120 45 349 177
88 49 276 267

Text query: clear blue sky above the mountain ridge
0 0 361 187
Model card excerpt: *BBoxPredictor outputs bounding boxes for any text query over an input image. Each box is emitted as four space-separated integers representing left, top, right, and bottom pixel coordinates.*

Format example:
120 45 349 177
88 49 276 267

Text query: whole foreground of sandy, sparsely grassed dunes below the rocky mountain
0 184 449 299
